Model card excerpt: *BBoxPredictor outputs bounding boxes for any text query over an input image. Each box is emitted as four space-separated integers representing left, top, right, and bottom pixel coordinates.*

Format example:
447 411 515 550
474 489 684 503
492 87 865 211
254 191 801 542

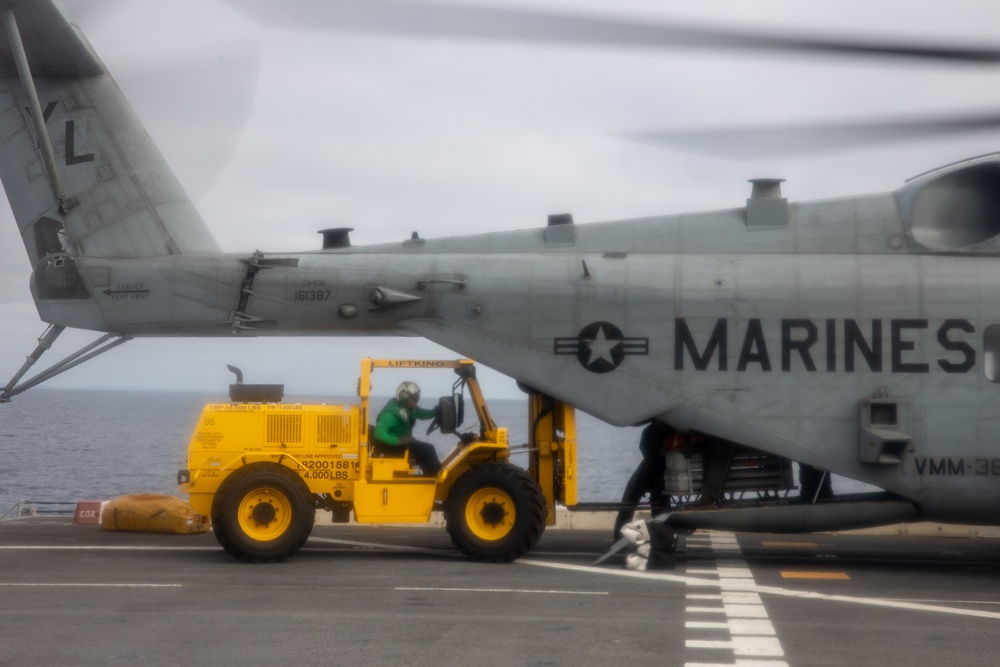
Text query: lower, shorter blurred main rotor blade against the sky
623 111 1000 160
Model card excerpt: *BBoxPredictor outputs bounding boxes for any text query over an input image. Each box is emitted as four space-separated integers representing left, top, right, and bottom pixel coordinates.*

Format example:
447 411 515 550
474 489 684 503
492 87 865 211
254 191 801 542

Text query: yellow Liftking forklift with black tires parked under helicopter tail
177 359 576 562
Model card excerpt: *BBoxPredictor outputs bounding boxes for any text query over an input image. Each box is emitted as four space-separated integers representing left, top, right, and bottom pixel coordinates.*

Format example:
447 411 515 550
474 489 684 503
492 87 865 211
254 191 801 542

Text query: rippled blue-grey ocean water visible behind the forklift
0 388 641 516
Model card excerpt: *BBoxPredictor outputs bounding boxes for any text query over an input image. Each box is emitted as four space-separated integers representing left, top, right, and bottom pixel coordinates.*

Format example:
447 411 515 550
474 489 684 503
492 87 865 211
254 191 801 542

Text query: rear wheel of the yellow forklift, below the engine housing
212 463 316 563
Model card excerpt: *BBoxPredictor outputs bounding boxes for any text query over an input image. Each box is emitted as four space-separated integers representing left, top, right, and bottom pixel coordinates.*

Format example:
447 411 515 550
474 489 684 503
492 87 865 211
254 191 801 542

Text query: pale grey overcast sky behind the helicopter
0 0 1000 396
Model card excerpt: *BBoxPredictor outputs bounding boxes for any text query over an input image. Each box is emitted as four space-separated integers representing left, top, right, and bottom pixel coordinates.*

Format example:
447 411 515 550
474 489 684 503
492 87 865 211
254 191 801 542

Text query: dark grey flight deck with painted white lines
0 518 1000 667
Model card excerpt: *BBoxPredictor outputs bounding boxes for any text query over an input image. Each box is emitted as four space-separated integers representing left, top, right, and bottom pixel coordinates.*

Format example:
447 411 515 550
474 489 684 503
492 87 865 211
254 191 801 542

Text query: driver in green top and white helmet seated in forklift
374 382 441 477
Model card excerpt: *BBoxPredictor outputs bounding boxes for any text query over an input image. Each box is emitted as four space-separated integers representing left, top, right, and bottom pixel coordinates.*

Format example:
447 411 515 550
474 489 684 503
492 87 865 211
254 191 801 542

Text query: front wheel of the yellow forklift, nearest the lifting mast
445 462 545 563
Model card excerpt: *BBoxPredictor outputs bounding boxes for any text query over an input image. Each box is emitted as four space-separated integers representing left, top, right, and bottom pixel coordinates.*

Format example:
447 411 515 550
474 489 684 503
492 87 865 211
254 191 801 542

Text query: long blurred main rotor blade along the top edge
227 0 1000 63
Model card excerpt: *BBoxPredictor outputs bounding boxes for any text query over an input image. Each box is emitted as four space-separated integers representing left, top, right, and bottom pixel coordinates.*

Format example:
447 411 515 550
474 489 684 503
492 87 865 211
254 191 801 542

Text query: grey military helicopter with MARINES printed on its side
0 2 1000 532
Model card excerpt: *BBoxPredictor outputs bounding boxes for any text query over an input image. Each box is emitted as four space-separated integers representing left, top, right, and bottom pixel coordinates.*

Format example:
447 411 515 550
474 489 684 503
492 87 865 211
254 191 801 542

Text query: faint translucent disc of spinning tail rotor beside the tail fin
67 0 260 199
